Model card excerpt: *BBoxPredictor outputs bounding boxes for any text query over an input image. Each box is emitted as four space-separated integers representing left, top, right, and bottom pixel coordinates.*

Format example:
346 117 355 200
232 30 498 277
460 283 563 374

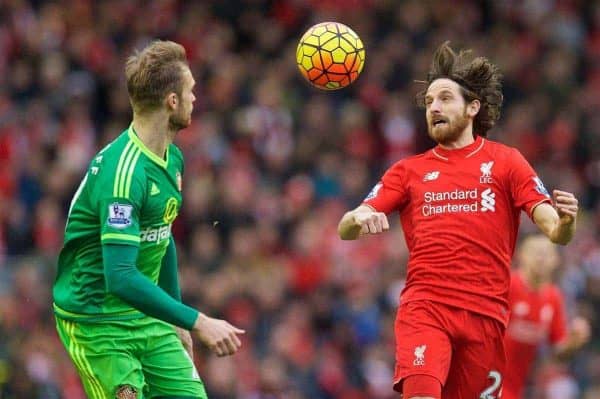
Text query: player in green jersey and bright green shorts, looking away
53 41 244 399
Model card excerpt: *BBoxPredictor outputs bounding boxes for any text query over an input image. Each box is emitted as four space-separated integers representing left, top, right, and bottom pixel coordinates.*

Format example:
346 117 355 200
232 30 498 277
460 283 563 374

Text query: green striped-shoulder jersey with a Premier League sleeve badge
53 127 183 321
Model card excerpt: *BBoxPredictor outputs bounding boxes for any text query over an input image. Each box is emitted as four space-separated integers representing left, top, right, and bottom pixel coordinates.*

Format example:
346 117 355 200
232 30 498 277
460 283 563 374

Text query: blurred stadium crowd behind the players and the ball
0 0 600 399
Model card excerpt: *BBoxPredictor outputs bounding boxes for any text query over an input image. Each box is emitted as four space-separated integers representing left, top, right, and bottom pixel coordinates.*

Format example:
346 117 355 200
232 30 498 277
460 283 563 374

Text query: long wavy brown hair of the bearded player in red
417 41 503 137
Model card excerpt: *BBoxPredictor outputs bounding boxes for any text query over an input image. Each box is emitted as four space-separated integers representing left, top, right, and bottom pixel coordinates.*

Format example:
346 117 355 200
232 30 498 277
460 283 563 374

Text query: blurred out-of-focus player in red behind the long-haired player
502 235 590 399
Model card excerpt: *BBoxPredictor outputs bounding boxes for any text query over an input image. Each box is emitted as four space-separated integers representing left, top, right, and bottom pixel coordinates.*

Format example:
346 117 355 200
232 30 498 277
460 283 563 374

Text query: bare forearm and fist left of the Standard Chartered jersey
338 204 390 240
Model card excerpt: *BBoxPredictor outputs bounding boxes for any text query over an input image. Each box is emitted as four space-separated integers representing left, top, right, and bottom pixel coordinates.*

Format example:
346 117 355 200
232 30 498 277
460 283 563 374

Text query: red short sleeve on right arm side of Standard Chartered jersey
509 149 552 217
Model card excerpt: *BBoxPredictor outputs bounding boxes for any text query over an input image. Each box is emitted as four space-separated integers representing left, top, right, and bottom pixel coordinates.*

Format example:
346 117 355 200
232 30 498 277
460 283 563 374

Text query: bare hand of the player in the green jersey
193 313 245 357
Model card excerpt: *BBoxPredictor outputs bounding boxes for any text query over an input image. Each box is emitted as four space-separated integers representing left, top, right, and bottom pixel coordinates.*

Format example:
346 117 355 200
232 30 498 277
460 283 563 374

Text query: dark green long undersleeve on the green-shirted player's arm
102 244 198 330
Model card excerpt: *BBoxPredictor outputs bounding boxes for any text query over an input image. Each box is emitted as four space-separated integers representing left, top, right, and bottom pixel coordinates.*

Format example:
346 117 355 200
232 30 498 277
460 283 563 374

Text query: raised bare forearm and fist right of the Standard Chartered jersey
533 190 579 245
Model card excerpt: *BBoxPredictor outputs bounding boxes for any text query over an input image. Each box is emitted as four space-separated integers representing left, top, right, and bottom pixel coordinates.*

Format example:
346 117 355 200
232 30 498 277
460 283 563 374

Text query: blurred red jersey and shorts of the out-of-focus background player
504 272 567 399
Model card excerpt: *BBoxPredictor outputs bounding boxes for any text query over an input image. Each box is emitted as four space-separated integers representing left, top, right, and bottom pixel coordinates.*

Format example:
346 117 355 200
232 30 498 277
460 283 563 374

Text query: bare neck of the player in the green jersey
133 112 174 159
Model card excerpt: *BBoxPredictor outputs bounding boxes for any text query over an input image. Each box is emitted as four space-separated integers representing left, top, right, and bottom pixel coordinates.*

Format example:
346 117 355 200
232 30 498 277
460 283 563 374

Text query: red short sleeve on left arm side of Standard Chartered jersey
363 161 407 214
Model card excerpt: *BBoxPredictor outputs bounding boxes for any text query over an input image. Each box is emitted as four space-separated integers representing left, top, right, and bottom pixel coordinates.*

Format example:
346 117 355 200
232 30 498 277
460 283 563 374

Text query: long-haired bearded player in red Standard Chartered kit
338 43 578 399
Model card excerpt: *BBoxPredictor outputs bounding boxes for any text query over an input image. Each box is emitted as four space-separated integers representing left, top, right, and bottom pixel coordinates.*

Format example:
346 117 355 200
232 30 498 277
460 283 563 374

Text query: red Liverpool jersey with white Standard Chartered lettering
364 136 551 326
